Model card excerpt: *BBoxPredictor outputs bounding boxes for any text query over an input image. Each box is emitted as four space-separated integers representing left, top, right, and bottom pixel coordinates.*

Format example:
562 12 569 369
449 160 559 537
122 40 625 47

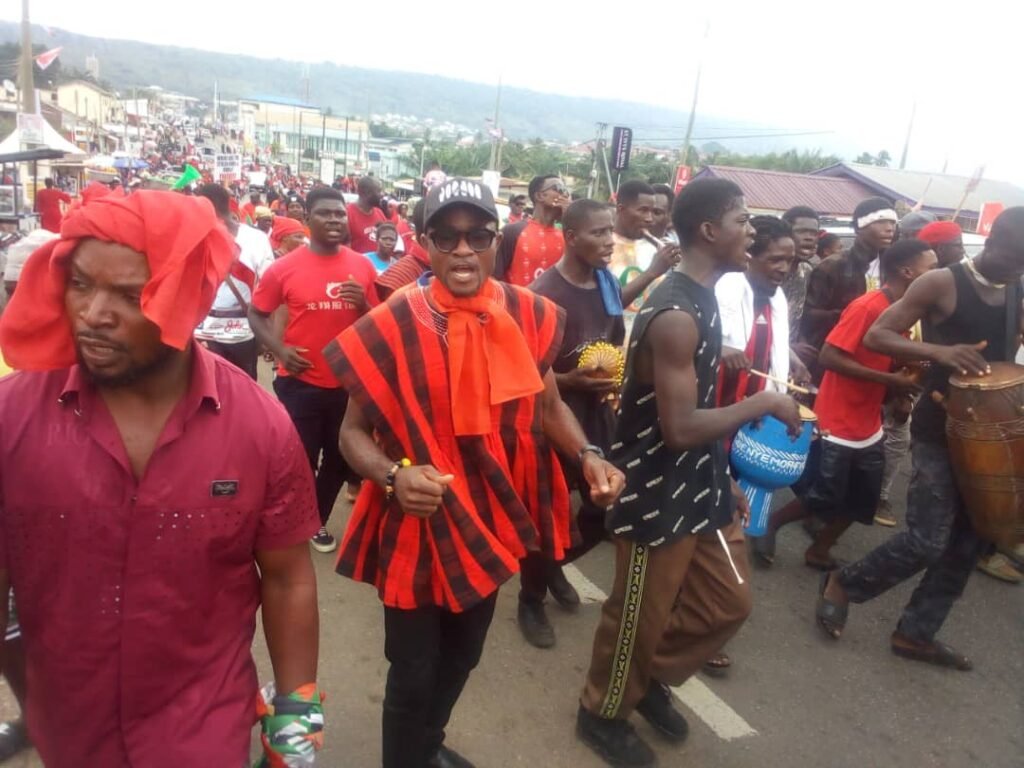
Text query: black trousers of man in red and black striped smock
382 592 498 768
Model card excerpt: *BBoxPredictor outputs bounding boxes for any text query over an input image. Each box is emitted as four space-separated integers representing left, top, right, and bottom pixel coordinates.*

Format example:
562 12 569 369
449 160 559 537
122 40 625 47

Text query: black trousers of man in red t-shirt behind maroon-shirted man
273 376 357 525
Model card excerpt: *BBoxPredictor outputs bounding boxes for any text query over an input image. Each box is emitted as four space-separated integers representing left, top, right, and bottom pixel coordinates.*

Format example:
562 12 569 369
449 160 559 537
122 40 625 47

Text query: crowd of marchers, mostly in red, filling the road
0 163 1024 768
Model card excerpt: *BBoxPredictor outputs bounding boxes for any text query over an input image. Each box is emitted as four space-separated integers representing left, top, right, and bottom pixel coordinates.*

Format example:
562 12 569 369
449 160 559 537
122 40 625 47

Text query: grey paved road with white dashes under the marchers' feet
0 393 1024 768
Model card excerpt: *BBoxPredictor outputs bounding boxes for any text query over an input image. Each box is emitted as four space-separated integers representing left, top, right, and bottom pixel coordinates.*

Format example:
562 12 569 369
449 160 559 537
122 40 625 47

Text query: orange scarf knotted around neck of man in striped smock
430 278 544 435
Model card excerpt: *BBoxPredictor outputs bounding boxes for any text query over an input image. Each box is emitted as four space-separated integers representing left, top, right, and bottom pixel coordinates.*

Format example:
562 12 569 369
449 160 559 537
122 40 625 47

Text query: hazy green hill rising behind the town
0 22 704 140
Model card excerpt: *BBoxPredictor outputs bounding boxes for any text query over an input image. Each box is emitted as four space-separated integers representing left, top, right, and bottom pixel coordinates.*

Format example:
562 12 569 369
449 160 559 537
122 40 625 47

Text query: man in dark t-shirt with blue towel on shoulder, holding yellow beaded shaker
518 200 626 648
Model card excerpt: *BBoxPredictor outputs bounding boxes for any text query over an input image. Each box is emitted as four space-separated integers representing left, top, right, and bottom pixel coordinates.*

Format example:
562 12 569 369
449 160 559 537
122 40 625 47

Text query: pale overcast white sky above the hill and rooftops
8 0 1024 185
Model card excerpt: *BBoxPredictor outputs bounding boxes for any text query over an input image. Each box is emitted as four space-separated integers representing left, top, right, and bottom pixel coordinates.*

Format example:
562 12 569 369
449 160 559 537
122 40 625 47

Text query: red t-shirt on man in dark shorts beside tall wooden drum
814 291 893 441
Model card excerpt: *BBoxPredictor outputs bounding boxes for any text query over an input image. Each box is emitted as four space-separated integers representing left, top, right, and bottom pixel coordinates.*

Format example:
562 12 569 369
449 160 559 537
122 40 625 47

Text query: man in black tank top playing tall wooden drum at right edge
815 207 1024 670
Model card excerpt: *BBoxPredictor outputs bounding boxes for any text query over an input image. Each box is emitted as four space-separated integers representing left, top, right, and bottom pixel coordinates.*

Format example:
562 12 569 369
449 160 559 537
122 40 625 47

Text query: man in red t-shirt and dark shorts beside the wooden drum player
761 240 938 570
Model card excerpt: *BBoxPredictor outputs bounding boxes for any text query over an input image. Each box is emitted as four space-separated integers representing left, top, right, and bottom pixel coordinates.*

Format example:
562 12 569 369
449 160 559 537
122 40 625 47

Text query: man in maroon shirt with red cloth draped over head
0 191 323 768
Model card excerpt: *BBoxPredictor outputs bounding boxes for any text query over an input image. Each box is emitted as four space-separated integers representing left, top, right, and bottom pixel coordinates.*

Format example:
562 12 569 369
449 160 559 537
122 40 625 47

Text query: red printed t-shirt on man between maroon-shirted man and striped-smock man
253 246 377 389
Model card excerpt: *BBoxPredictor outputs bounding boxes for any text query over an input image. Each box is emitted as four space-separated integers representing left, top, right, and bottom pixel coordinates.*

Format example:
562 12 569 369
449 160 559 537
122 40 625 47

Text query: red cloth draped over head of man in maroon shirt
0 191 236 371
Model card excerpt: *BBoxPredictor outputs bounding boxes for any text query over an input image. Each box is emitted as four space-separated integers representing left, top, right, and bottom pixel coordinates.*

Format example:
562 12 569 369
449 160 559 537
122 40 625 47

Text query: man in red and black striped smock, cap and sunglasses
325 179 623 768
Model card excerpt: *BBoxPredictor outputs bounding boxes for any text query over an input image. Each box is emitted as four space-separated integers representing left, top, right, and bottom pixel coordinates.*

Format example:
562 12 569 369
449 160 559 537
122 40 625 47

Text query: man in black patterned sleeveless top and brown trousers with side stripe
577 179 800 768
